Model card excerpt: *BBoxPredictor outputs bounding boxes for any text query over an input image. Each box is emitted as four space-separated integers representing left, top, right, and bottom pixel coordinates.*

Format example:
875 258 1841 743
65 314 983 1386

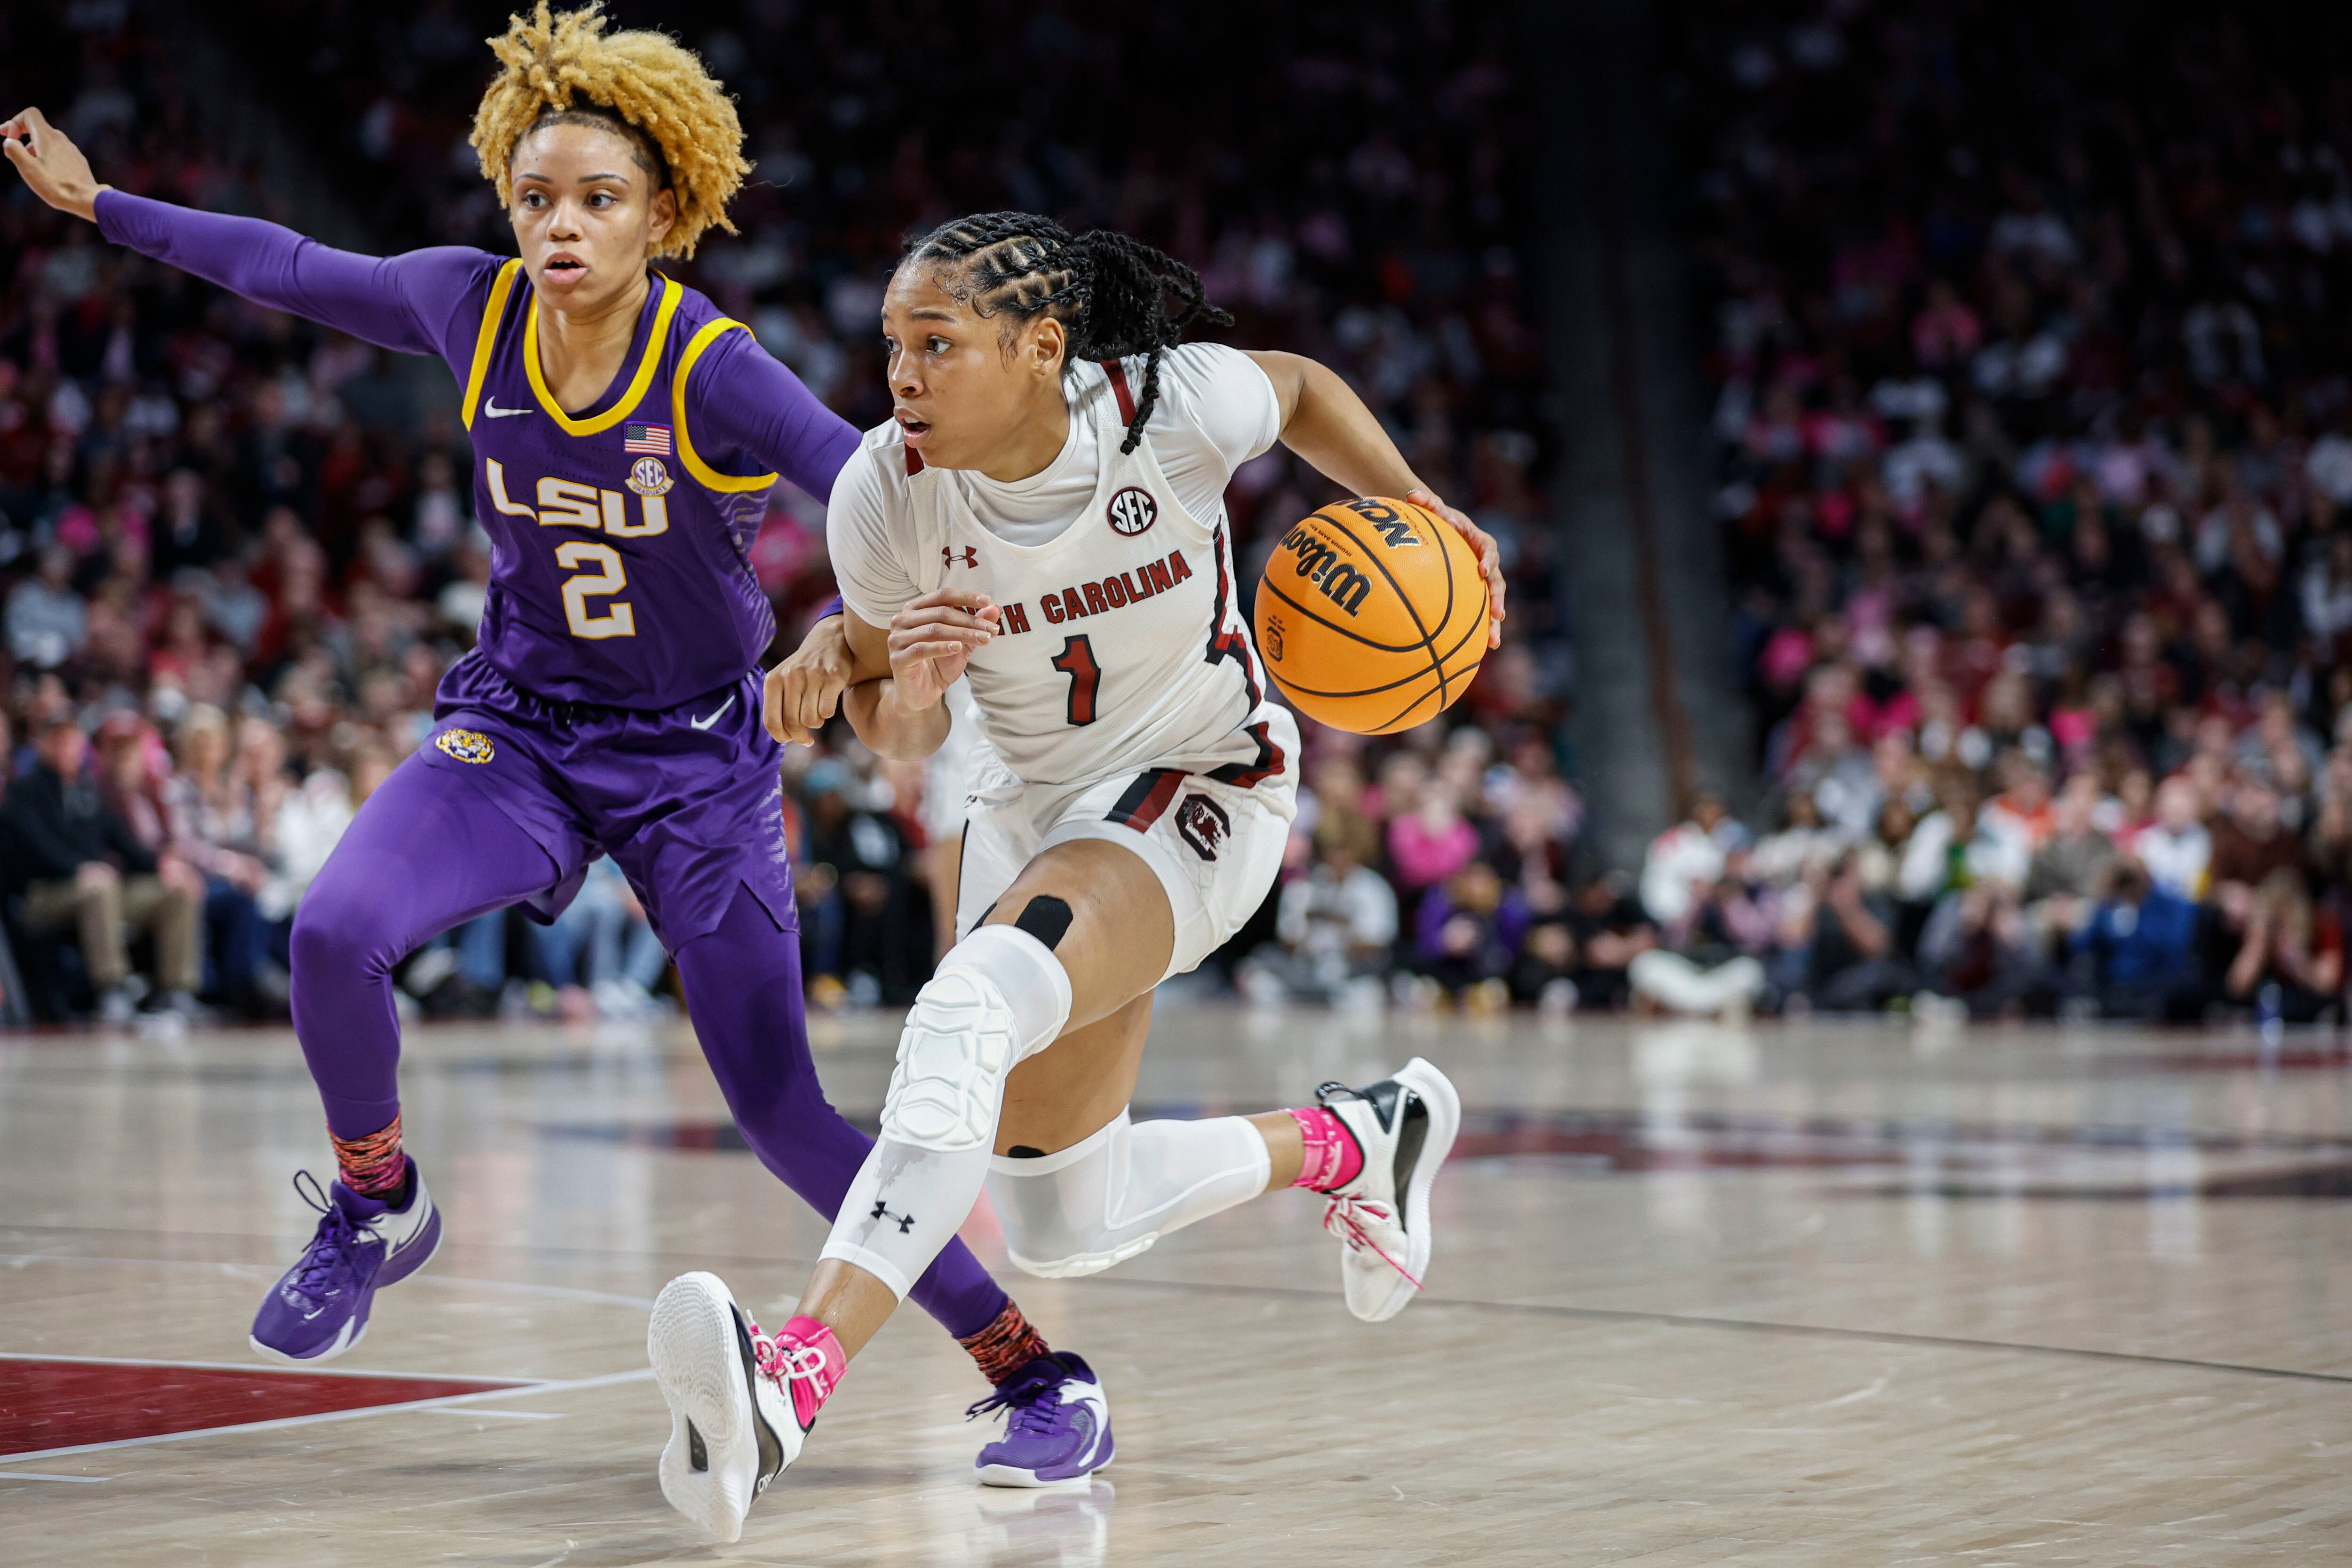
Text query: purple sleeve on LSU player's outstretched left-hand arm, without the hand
99 191 499 358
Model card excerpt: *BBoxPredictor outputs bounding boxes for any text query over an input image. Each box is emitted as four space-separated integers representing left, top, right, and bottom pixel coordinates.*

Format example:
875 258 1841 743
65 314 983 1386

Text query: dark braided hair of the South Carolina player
906 212 1232 451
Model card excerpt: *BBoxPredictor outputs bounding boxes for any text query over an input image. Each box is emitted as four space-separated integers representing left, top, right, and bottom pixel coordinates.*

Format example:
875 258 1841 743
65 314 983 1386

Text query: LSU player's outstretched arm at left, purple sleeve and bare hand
0 108 463 355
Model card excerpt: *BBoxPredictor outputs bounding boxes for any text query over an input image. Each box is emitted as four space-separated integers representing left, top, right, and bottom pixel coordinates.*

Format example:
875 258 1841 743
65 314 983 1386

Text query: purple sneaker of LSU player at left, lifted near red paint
249 1159 440 1361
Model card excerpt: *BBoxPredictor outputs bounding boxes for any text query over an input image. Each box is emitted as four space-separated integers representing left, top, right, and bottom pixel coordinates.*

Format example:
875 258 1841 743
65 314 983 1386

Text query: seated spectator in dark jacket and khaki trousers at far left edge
0 715 200 1023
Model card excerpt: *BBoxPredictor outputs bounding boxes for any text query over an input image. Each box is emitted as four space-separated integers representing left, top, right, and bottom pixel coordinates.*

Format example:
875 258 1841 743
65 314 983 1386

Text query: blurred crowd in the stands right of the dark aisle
1642 0 2352 1018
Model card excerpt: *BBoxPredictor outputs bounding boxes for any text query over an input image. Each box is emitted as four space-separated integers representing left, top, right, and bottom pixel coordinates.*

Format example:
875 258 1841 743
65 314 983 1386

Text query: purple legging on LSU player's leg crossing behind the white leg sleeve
677 889 1004 1337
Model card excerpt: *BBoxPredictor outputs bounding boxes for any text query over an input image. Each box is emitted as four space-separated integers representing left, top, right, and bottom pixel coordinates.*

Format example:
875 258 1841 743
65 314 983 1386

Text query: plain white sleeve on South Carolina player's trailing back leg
988 1110 1272 1279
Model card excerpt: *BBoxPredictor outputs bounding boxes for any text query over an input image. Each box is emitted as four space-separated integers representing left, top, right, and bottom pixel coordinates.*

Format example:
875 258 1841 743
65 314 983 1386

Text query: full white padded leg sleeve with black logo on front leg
818 926 1070 1300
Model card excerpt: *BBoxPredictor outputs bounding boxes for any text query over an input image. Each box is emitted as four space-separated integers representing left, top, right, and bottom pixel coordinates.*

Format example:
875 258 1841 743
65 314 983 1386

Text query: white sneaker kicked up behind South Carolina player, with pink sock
1315 1056 1463 1323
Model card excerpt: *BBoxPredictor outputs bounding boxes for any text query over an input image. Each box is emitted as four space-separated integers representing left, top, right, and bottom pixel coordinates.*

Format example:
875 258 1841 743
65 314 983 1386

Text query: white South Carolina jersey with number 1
826 357 1298 788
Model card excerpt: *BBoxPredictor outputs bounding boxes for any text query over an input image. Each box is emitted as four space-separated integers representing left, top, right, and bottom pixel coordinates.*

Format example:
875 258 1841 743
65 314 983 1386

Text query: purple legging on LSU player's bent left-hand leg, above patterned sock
292 757 555 1138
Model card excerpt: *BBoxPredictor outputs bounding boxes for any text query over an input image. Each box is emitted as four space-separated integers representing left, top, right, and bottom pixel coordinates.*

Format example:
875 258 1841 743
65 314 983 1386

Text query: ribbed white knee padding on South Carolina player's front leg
882 926 1070 1154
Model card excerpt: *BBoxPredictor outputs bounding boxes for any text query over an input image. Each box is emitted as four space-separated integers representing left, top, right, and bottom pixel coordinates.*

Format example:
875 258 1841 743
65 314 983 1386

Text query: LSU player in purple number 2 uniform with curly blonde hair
0 2 1091 1457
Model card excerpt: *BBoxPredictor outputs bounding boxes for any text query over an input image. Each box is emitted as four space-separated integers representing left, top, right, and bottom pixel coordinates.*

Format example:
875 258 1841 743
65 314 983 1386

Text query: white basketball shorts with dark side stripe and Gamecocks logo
955 743 1298 980
